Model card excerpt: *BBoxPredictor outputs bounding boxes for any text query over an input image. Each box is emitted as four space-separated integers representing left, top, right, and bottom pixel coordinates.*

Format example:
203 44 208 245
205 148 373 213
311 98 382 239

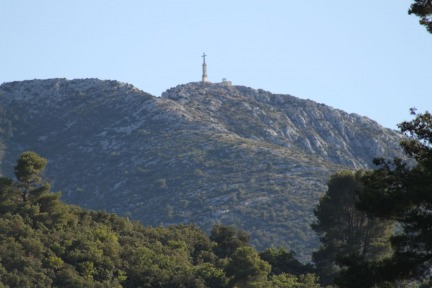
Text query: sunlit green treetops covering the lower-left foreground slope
0 152 319 288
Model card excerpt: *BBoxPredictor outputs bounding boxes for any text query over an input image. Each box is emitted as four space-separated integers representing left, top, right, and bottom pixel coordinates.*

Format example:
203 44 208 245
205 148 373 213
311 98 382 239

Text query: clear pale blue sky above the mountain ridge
0 0 432 129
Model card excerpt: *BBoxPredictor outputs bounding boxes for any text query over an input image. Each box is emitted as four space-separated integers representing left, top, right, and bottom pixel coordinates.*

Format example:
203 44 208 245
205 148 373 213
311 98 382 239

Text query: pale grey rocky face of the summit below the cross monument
162 83 400 169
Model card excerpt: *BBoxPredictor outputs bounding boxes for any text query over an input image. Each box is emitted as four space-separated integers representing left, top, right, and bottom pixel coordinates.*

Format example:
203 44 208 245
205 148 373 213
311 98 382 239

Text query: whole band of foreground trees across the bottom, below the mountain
0 113 432 288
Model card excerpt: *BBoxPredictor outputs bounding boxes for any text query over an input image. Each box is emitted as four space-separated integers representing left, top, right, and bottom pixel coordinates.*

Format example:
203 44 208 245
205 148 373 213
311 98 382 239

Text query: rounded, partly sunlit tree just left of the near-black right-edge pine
311 171 392 285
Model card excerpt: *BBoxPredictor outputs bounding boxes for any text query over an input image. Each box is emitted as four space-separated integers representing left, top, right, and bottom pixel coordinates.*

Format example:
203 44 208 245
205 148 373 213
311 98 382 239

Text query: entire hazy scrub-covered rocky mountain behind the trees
0 79 402 257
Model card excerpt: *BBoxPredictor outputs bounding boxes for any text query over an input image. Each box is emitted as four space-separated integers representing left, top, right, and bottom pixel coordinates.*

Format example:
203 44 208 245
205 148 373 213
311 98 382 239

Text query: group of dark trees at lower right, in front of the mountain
308 109 432 288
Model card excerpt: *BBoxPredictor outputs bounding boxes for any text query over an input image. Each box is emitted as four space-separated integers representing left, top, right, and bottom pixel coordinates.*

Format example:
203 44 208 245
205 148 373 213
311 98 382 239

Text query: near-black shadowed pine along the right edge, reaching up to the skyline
358 109 432 284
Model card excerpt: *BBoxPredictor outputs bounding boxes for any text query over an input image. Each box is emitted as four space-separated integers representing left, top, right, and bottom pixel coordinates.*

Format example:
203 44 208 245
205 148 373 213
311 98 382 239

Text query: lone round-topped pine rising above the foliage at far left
15 151 47 201
